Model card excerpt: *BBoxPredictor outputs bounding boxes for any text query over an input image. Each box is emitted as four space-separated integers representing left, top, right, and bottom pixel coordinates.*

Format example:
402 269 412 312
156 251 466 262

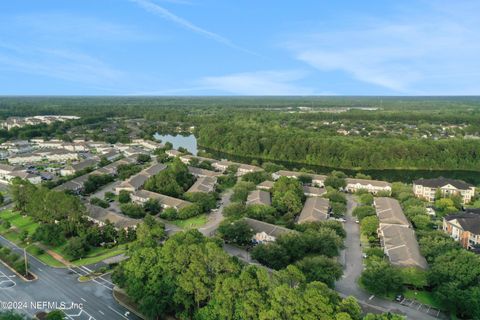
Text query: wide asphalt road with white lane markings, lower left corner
0 237 139 320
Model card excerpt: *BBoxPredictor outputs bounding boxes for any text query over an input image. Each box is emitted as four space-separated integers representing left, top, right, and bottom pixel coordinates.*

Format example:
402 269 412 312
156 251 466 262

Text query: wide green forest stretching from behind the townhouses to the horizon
0 97 480 174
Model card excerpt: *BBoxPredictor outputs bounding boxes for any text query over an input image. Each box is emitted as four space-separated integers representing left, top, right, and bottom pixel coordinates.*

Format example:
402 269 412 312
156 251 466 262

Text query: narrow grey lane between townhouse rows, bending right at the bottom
335 195 438 320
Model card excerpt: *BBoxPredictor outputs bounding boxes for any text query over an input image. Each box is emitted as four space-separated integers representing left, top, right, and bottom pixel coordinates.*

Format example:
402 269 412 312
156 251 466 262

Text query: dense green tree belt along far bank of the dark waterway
199 122 480 170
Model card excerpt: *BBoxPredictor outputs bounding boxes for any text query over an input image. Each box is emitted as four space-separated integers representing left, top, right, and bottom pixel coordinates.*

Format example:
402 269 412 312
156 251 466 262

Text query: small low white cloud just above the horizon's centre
200 70 314 95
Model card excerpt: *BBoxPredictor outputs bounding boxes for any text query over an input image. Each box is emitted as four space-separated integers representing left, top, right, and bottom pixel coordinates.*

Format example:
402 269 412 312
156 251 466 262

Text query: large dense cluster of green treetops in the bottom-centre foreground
113 226 392 320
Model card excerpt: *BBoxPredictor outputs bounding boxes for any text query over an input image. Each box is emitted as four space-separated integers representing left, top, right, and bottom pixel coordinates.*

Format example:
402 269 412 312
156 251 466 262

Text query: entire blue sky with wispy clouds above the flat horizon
0 0 480 95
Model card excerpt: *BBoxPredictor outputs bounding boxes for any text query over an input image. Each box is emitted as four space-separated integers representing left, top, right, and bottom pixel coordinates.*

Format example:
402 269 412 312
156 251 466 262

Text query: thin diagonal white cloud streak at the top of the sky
130 0 255 54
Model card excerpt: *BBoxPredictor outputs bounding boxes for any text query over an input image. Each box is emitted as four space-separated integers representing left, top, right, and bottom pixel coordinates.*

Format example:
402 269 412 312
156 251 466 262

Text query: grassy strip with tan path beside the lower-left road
0 210 125 268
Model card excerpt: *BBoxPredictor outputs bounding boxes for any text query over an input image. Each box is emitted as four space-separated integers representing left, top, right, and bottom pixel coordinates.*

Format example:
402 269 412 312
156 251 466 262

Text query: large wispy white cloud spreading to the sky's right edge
286 1 480 94
